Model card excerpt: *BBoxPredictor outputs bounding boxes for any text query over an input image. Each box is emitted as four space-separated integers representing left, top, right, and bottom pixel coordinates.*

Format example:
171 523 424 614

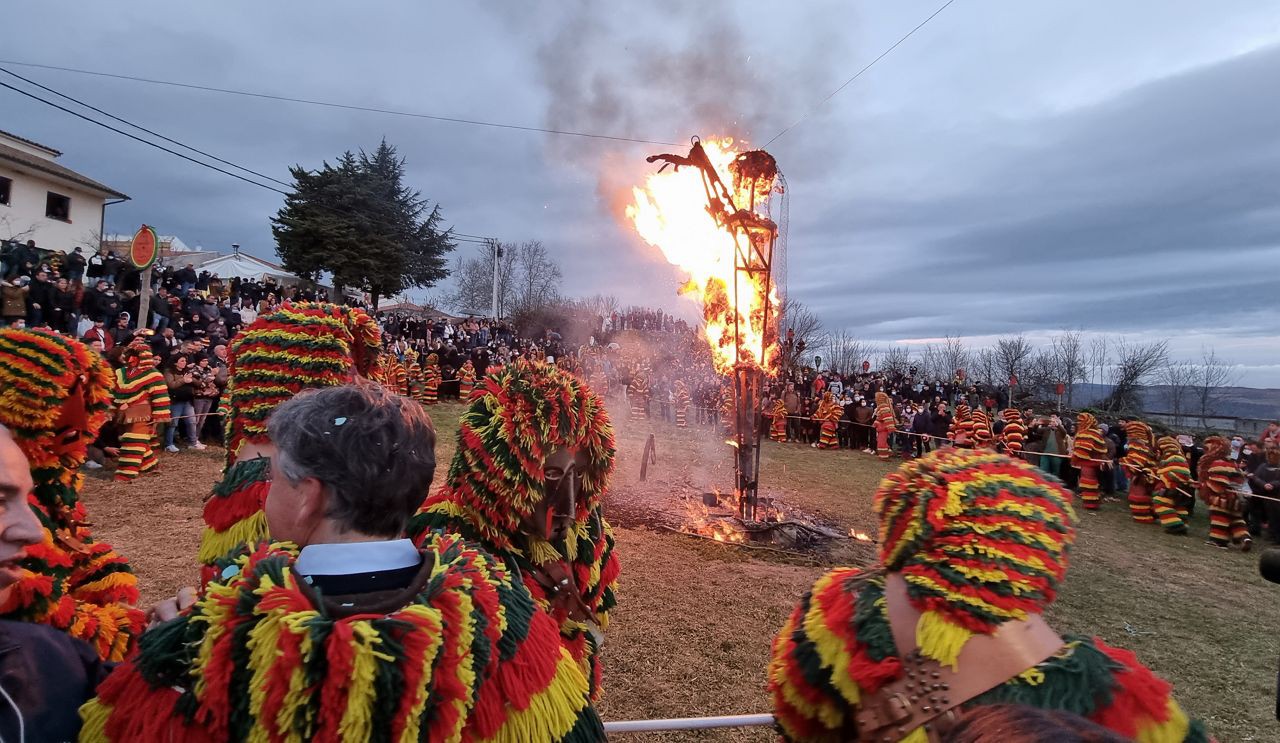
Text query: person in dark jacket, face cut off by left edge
0 427 106 740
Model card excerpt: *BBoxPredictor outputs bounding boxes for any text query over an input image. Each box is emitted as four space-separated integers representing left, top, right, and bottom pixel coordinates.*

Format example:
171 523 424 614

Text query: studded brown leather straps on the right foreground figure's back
854 573 1062 742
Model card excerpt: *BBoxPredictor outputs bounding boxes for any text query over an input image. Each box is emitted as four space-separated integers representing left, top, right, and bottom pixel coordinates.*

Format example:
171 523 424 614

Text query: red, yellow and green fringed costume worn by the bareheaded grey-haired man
81 535 604 743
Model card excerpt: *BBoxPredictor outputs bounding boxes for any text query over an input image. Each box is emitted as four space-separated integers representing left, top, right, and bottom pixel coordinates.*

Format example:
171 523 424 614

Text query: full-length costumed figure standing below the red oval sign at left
114 336 169 482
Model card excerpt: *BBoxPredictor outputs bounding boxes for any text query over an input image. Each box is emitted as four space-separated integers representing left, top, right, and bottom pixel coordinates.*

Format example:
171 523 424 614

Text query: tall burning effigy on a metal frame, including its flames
626 138 778 520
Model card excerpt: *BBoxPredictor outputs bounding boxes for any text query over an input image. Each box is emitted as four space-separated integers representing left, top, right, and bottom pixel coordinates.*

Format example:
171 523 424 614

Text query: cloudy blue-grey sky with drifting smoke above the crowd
0 0 1280 386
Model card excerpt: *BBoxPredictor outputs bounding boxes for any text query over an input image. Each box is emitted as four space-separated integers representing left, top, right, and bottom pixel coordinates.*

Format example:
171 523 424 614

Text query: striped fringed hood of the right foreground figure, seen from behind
874 448 1075 652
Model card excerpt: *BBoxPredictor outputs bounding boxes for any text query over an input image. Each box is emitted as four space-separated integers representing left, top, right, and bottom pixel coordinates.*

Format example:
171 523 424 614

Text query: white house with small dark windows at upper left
0 131 128 252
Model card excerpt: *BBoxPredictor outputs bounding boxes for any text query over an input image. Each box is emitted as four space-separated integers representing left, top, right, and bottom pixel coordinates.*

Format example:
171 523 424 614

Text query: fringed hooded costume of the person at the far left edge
0 328 146 661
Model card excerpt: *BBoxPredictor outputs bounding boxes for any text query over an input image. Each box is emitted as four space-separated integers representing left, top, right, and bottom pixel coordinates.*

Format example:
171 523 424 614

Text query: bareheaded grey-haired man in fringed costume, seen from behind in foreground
79 384 604 743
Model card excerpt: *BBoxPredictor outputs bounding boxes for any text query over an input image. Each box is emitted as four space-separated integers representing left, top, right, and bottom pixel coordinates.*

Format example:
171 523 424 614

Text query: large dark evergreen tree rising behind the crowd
271 140 454 310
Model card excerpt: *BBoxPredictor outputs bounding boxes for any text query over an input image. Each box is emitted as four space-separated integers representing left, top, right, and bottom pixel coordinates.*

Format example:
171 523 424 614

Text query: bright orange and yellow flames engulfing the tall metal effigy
626 138 778 375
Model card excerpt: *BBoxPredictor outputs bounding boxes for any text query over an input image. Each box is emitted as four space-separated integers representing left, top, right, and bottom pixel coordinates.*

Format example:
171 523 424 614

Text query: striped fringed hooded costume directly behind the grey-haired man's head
198 302 380 580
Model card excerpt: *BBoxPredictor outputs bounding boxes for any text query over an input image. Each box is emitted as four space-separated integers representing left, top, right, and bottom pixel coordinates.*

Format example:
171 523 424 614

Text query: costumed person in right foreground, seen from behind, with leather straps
768 448 1207 743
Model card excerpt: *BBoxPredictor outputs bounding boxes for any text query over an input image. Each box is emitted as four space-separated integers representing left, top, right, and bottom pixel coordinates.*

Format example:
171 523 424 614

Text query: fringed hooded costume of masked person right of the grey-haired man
410 361 620 698
